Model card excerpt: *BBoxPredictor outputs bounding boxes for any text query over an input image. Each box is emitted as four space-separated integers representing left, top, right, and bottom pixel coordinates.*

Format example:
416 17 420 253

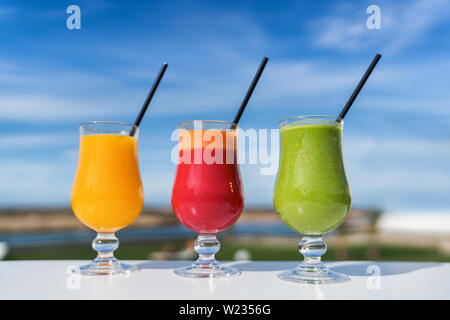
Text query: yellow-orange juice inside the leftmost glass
71 134 144 233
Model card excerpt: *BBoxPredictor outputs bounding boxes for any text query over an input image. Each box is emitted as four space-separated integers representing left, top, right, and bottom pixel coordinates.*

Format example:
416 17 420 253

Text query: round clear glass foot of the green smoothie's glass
278 265 350 284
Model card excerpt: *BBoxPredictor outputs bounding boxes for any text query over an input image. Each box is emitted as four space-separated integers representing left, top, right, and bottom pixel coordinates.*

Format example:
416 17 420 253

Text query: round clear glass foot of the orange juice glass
72 259 140 276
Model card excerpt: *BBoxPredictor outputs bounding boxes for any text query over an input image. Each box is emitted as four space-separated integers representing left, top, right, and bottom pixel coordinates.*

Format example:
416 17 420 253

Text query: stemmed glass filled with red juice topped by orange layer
172 120 244 278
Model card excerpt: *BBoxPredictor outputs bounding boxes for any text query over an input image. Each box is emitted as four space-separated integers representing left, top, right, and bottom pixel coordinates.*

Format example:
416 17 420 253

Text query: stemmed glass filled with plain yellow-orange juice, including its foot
71 121 144 275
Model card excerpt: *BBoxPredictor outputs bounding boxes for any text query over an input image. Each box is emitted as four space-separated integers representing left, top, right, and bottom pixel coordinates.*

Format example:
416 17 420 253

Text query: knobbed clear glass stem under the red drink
194 233 220 268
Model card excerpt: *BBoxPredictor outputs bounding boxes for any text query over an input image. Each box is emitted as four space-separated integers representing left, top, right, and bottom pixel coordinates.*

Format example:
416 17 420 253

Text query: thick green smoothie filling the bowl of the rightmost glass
273 120 351 235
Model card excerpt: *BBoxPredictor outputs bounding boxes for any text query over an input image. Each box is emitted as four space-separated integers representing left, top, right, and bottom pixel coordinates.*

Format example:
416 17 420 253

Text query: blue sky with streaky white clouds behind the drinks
0 0 450 210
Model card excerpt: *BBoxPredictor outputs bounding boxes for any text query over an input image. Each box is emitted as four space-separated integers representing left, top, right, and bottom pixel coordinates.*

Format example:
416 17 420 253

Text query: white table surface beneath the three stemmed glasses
0 261 450 300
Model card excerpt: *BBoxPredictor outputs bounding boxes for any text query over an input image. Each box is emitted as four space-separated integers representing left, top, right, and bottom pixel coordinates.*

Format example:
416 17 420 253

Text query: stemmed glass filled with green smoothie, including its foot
273 116 351 284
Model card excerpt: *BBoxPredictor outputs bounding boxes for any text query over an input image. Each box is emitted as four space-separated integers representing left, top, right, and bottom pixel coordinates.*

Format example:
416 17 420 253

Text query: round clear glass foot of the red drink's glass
174 263 241 278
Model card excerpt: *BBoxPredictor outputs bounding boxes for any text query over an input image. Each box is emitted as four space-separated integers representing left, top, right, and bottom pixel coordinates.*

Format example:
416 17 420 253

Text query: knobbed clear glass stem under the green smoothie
297 235 327 272
